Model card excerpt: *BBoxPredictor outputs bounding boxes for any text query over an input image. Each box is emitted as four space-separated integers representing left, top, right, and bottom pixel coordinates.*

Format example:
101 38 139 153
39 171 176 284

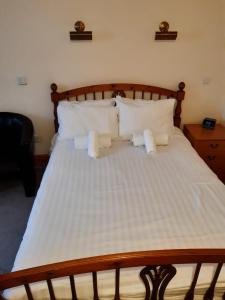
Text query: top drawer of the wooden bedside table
194 141 225 159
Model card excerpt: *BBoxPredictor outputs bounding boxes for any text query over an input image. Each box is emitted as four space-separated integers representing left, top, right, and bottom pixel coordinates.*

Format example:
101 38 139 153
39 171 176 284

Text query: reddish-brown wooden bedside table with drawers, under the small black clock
183 124 225 183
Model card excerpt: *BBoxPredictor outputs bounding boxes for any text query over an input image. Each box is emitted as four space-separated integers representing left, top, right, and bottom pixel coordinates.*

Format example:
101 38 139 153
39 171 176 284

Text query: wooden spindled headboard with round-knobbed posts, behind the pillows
51 82 185 132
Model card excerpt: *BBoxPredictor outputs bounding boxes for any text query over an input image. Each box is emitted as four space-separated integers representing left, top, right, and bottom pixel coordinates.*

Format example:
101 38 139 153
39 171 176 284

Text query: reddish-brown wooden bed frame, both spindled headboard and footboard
0 82 225 300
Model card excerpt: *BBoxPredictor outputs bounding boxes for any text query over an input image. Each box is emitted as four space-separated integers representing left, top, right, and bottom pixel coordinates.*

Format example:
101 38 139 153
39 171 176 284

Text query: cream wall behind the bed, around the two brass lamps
0 0 225 153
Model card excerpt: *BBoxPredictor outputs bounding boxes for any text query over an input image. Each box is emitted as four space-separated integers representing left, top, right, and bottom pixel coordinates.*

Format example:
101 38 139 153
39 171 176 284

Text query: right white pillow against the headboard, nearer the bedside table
117 99 175 139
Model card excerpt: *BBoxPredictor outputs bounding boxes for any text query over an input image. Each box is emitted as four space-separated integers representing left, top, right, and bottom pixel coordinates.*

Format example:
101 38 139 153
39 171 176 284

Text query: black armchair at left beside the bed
0 112 36 197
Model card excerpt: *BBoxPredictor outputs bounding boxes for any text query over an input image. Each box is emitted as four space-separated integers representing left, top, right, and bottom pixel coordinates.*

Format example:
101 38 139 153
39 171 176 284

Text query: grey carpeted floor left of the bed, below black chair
0 170 43 274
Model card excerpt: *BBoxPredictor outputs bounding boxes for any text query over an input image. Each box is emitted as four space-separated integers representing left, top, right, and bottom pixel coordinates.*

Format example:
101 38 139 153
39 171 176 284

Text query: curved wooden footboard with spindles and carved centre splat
0 249 225 300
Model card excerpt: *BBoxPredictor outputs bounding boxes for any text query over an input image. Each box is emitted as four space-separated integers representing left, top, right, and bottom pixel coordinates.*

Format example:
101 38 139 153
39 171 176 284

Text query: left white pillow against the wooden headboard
57 101 118 140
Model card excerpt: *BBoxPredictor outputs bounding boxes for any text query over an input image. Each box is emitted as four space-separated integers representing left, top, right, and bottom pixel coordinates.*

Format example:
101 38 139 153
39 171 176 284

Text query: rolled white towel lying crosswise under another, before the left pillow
74 134 112 149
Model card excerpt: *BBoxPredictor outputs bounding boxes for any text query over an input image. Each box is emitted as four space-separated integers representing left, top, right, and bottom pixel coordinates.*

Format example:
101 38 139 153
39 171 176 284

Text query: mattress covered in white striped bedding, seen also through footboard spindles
5 130 225 299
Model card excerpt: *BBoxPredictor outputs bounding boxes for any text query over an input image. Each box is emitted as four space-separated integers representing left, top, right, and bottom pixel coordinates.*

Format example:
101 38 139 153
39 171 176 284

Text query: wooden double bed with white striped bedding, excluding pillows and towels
0 82 225 300
